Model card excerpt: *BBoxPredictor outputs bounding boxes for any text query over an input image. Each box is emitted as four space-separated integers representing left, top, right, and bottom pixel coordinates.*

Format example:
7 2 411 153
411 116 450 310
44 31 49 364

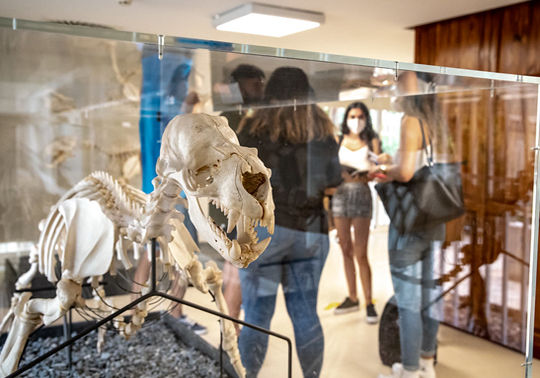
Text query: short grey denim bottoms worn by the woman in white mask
332 182 373 219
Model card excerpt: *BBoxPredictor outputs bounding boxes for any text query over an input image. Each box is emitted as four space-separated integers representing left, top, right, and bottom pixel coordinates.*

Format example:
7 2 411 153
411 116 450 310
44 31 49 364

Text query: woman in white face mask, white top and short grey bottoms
332 102 381 324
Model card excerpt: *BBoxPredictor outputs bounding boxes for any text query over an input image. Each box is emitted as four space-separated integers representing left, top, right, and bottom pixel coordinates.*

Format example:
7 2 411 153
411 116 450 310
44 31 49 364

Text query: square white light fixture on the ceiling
212 3 324 37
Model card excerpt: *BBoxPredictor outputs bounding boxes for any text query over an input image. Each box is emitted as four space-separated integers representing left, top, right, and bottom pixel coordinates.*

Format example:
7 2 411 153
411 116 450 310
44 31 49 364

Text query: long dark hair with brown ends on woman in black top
238 67 335 144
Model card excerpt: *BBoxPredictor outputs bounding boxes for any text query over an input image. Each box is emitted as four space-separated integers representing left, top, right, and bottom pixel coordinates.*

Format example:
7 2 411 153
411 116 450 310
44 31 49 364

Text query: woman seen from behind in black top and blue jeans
238 67 341 377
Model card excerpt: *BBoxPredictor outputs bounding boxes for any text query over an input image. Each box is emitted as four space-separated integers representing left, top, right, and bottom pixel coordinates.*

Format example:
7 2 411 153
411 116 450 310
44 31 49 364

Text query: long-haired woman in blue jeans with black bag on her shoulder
372 72 452 378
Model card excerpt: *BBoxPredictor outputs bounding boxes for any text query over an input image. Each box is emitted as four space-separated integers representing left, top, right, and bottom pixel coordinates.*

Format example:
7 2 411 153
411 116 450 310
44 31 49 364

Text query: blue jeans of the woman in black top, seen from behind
239 226 329 378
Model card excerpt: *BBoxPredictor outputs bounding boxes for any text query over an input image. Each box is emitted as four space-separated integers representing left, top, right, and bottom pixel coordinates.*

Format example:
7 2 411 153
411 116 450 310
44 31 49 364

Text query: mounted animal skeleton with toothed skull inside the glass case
0 114 274 377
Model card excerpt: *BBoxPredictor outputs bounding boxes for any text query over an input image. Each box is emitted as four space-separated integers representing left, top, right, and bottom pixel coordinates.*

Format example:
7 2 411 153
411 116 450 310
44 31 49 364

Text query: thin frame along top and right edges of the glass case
0 18 540 377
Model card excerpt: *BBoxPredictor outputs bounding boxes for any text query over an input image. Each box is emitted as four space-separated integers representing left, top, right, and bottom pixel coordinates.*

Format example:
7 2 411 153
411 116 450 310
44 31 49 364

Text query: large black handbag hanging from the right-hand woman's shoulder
375 122 465 234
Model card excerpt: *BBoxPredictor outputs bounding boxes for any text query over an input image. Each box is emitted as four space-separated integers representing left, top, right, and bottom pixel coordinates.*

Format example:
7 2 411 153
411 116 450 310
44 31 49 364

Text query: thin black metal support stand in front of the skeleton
6 239 292 378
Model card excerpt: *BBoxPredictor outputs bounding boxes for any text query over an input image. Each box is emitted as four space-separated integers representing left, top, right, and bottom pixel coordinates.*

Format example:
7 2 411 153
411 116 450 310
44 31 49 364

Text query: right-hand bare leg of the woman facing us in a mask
352 218 373 305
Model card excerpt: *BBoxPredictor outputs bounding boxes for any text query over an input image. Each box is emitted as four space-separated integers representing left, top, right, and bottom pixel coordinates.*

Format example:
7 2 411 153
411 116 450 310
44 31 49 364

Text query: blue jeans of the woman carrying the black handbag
388 224 445 371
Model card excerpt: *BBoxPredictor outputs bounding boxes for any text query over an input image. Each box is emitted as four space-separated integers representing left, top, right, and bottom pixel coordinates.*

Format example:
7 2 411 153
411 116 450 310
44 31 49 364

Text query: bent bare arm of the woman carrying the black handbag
370 116 422 182
